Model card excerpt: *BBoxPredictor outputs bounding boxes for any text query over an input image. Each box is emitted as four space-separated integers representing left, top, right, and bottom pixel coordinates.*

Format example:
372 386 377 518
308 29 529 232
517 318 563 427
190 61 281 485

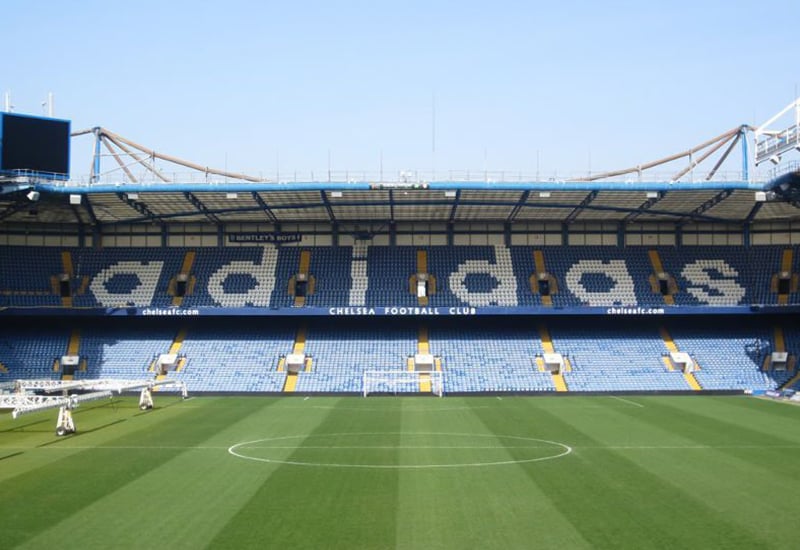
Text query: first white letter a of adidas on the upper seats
89 261 164 307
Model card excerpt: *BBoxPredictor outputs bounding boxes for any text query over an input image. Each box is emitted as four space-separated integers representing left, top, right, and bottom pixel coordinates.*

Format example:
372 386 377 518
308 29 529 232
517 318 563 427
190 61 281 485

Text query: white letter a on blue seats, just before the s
565 260 636 306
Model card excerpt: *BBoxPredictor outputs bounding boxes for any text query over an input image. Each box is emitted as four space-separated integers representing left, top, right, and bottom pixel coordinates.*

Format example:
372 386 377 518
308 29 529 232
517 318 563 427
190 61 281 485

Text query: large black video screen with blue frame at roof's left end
0 113 70 179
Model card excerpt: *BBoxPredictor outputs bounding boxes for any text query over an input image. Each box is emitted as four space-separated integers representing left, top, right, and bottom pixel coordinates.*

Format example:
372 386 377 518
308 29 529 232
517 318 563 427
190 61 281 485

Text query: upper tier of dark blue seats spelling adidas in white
0 246 800 308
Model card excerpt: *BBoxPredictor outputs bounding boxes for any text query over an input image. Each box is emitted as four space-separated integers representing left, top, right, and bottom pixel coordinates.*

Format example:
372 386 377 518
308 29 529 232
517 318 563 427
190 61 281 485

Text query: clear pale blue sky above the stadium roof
0 0 800 179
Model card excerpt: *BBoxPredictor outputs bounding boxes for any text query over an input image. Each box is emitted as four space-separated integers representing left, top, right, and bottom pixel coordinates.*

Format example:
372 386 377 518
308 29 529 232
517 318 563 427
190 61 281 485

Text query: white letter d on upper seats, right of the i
448 245 518 307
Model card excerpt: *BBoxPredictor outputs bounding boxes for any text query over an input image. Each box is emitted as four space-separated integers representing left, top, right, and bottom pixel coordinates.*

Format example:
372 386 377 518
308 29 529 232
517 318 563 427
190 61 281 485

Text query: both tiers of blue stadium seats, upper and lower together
0 241 800 393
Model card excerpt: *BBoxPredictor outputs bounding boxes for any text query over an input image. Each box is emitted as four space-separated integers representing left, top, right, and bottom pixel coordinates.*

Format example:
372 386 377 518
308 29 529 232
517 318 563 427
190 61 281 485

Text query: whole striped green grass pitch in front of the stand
0 395 800 549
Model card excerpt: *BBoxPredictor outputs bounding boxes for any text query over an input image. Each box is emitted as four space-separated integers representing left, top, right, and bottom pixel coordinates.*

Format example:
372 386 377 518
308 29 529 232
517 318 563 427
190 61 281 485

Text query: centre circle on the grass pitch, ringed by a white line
228 432 572 470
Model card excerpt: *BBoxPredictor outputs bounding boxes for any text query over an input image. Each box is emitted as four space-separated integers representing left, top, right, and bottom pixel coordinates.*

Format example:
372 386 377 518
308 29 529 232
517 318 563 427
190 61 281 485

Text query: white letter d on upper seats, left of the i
208 246 278 307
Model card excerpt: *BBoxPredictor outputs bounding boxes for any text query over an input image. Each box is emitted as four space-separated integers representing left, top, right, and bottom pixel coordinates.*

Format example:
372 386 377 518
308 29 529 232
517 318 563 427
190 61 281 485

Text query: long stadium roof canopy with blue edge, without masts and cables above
0 177 800 229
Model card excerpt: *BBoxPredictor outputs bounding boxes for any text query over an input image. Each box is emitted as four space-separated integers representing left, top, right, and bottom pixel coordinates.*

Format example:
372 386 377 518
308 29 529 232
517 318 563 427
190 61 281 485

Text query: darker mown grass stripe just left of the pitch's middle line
209 399 402 549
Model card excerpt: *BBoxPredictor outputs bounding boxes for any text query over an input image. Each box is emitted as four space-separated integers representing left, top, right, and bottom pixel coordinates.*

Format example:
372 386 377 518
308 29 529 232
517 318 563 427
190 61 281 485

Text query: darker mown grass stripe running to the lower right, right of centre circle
468 400 766 548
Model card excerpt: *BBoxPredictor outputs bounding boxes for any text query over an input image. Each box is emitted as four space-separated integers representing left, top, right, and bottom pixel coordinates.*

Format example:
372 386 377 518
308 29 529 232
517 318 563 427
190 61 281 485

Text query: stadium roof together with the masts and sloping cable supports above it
0 98 800 227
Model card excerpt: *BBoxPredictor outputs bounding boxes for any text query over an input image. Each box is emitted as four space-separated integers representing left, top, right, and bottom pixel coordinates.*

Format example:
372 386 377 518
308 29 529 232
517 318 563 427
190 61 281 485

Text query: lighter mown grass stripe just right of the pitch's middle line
396 398 589 550
